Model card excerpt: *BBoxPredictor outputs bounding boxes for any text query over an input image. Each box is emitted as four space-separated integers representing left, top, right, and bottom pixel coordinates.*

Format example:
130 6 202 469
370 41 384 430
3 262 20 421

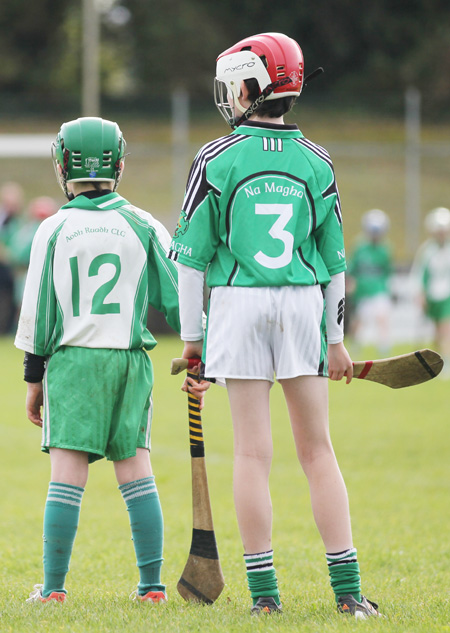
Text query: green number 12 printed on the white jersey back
69 253 122 317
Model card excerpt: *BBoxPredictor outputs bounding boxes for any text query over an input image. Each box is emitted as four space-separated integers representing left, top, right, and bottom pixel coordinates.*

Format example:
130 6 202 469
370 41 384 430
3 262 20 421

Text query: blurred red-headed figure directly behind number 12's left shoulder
6 196 59 308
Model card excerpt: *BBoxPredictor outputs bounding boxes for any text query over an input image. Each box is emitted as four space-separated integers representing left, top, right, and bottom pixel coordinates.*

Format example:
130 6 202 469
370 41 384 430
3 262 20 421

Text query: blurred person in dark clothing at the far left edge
0 182 24 334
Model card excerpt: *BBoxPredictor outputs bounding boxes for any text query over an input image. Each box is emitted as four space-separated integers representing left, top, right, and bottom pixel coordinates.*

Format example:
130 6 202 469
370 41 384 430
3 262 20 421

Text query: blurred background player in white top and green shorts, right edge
411 207 450 376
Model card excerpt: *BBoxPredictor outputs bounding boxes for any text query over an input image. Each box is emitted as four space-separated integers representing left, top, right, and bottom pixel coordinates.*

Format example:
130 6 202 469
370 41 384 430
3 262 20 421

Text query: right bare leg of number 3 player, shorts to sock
280 376 353 552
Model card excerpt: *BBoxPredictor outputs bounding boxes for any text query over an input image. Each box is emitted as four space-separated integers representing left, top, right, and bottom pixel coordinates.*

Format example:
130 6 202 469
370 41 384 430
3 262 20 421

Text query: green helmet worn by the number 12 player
52 117 126 197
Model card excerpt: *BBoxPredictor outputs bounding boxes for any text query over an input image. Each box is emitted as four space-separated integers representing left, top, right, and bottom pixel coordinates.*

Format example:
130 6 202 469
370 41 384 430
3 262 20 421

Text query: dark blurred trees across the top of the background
0 0 450 119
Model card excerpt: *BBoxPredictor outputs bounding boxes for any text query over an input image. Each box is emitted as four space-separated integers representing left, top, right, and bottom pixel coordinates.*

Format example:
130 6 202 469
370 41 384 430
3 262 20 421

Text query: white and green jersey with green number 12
15 193 180 356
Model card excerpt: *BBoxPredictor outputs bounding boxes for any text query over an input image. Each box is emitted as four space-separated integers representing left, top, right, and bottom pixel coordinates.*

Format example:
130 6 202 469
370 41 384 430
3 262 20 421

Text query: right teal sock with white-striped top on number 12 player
119 477 166 596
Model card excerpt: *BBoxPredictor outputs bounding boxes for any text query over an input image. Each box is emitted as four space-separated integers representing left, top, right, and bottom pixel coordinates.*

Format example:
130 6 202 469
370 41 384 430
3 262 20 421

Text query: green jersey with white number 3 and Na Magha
169 121 346 287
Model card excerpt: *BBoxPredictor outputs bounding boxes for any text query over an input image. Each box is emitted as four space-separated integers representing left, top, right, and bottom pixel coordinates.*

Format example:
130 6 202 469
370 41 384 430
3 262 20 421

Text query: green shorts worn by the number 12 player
42 347 153 462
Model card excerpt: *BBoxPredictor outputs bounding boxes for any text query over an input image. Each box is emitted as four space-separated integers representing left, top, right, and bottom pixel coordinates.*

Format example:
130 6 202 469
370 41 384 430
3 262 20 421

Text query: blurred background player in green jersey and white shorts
347 209 392 356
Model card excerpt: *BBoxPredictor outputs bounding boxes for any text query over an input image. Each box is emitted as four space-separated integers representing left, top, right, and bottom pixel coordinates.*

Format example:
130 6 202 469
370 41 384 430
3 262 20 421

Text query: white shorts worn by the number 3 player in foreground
205 286 328 382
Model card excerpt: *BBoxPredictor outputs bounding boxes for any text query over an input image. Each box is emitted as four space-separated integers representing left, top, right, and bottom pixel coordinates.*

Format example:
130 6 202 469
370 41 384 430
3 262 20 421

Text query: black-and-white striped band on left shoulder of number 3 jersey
183 135 246 219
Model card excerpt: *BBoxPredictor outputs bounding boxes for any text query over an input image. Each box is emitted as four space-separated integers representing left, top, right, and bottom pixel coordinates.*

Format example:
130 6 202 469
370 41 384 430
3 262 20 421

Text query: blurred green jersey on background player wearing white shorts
348 241 392 301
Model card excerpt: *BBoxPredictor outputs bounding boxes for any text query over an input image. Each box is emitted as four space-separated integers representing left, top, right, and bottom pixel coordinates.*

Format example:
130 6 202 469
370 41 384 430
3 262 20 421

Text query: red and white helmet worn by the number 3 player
214 33 304 127
